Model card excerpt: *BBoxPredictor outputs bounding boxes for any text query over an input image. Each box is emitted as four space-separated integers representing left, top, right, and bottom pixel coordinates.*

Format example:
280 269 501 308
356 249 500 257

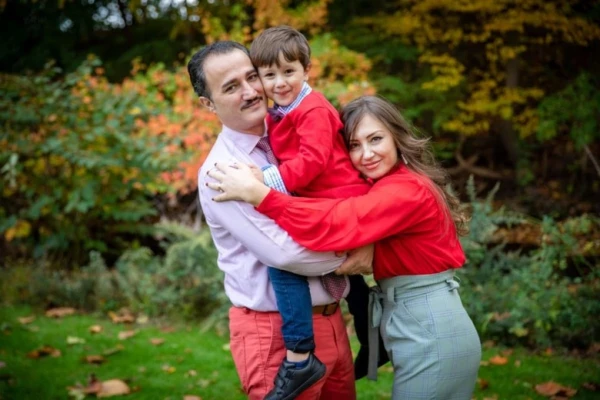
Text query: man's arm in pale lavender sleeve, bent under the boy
198 176 344 276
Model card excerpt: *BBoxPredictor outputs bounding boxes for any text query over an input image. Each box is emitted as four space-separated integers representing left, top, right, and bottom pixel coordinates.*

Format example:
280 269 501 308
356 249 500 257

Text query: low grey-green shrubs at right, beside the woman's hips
459 179 600 347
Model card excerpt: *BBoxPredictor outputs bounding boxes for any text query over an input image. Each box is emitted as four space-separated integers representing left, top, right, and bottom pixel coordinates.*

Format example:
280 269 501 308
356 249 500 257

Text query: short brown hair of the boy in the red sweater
250 25 310 69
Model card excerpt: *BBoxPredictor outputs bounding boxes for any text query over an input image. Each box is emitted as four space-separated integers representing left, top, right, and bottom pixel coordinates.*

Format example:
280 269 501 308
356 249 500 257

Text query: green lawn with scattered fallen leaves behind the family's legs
0 307 600 400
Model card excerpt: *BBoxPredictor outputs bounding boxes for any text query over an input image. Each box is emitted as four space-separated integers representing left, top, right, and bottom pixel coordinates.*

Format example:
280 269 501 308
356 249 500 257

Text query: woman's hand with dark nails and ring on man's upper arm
206 162 270 206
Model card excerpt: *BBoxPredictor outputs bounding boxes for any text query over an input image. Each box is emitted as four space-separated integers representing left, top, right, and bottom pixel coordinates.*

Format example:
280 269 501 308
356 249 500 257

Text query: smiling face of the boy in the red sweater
258 53 310 106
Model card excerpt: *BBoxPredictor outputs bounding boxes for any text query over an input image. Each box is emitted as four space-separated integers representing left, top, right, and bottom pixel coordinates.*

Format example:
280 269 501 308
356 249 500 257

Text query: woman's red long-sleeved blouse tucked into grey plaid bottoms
257 166 465 280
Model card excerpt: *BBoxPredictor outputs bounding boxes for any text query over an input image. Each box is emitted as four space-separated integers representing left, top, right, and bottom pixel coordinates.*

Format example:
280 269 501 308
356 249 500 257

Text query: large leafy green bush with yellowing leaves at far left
0 58 180 262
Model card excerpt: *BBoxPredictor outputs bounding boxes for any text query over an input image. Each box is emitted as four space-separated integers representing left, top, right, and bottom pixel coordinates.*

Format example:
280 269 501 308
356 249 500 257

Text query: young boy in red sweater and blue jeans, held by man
250 26 376 399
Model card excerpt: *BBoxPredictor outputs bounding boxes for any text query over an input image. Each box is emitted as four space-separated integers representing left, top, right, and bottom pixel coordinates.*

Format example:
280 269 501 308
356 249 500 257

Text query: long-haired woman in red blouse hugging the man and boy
209 96 481 400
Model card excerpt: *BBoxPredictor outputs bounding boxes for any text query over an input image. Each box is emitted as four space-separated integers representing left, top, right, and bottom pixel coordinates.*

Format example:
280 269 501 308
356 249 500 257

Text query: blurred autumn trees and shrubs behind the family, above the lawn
0 0 600 397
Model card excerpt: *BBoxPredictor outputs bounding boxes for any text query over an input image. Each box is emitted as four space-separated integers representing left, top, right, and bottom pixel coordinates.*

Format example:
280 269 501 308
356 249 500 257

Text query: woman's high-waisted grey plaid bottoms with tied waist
370 270 481 400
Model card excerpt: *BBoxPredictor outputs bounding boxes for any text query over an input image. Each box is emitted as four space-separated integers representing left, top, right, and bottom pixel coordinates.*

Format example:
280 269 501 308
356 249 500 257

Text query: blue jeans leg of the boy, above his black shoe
268 267 315 353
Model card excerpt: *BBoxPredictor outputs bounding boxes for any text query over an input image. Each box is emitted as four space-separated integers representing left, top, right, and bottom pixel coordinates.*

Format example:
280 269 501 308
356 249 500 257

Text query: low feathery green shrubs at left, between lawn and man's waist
0 223 229 324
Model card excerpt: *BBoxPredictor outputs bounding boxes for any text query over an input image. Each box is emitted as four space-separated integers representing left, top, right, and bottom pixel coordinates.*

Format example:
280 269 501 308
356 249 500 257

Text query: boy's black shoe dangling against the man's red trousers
265 353 325 400
